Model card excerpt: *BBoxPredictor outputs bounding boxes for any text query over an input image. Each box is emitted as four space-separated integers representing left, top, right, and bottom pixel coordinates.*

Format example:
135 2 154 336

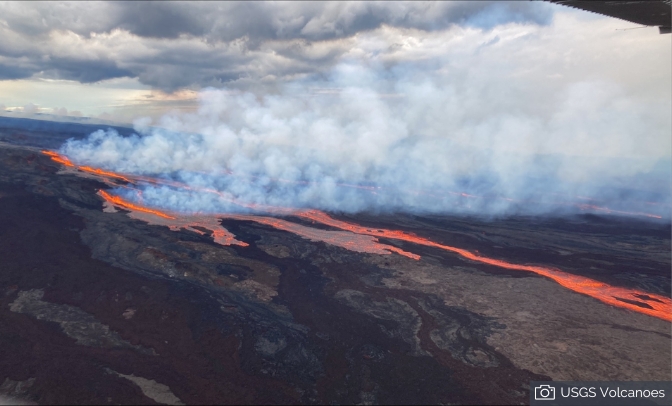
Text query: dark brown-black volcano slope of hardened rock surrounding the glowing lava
0 138 672 404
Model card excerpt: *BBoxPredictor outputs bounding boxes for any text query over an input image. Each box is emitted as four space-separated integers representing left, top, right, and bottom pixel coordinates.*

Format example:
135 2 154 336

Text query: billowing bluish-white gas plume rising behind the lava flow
61 53 670 218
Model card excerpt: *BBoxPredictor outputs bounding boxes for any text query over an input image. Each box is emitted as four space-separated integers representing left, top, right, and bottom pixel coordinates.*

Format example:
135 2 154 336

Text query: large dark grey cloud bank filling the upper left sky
0 2 553 91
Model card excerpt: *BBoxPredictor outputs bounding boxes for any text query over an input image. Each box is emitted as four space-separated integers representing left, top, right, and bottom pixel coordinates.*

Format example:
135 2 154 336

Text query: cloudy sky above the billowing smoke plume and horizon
0 2 670 122
